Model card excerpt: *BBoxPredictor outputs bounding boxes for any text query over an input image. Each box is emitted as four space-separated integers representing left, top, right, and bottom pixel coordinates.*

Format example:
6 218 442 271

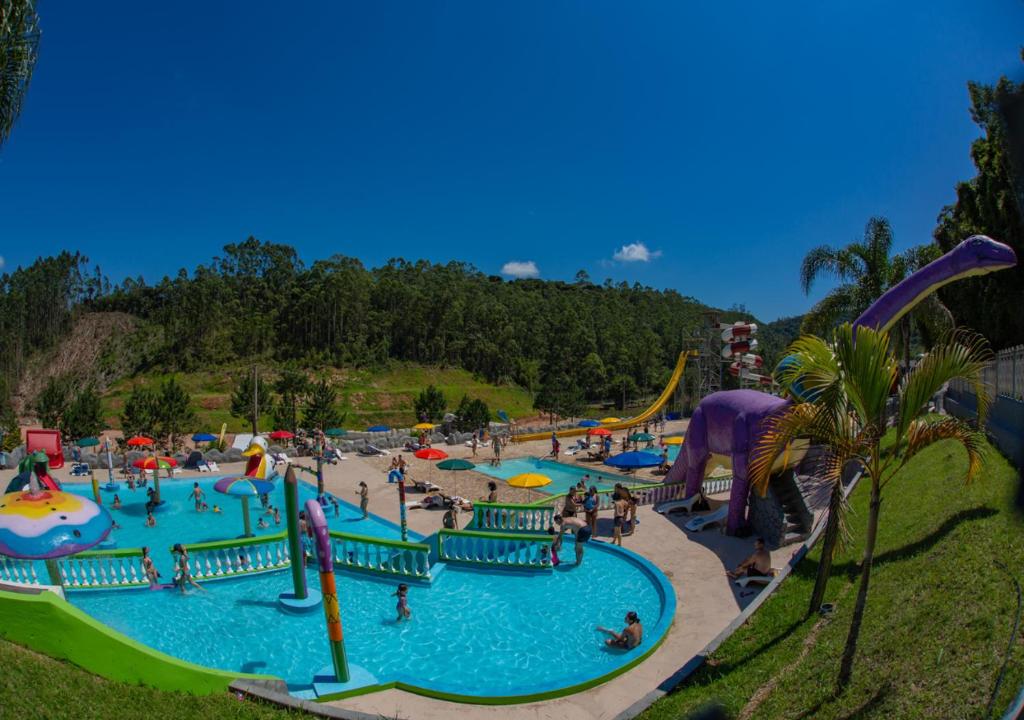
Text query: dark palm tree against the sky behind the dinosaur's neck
800 217 952 367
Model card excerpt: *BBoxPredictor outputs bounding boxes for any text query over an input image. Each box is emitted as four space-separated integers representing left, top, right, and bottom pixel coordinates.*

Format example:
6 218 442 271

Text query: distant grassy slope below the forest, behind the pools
102 363 536 432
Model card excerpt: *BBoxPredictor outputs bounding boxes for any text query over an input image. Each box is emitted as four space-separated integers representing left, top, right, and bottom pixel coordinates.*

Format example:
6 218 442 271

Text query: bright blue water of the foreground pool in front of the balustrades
69 544 675 696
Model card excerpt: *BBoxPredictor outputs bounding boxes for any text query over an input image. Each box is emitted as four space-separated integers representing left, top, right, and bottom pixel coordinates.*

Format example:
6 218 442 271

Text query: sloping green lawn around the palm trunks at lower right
641 434 1024 720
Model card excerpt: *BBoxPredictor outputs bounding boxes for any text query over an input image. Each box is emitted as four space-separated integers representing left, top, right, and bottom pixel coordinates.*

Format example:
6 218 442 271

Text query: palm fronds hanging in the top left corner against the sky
0 0 39 146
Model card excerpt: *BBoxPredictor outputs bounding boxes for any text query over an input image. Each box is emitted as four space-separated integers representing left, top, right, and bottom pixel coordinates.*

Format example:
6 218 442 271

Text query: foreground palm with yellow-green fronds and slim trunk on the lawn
751 323 991 690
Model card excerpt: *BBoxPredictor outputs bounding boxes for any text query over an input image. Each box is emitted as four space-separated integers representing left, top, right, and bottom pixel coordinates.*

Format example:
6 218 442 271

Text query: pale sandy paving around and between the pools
48 422 796 720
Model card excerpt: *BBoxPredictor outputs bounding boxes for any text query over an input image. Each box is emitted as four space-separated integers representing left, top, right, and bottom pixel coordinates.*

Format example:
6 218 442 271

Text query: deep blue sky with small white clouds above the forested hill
0 0 1024 320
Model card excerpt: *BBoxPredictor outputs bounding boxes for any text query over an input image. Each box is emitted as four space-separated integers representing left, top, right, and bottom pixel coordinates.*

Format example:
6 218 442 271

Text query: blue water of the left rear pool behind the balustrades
65 476 400 578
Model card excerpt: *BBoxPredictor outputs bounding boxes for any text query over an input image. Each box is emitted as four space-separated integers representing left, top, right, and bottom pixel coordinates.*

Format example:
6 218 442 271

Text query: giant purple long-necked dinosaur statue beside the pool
665 236 1017 535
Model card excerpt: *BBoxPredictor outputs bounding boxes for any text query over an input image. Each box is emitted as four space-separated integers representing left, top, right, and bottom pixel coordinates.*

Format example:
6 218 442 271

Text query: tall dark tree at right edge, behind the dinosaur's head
934 63 1024 347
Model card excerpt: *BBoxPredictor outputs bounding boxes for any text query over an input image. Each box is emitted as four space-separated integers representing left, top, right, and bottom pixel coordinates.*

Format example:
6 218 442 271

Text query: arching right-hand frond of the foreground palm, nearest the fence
896 330 992 437
